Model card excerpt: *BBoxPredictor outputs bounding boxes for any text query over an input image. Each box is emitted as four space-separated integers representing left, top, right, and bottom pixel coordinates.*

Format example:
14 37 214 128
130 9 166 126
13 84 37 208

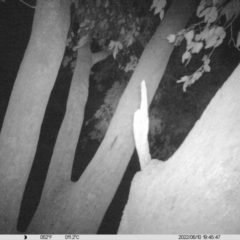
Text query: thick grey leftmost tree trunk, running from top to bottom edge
0 0 70 233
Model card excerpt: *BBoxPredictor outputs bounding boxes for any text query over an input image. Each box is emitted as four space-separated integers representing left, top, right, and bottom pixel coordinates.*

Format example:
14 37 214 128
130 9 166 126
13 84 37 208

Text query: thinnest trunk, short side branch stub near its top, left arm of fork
28 43 110 233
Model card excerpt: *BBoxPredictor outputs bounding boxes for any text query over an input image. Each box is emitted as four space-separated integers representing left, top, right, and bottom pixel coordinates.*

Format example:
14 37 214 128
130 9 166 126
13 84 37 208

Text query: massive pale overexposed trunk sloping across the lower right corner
118 65 240 234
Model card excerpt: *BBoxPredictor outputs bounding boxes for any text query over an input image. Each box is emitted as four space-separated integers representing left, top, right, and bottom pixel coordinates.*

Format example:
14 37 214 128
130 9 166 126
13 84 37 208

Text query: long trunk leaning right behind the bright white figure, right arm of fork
27 0 198 234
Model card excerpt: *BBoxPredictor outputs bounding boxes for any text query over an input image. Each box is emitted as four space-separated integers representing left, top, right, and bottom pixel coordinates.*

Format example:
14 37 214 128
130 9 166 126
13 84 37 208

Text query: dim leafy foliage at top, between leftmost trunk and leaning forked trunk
63 0 159 71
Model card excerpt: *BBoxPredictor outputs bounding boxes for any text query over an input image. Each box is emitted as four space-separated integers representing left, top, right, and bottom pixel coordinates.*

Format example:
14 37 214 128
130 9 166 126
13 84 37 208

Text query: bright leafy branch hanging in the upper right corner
168 0 240 91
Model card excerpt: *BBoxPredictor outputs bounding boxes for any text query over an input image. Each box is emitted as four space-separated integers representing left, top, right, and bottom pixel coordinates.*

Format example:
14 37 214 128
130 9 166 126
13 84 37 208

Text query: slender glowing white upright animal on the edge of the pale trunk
133 80 151 170
